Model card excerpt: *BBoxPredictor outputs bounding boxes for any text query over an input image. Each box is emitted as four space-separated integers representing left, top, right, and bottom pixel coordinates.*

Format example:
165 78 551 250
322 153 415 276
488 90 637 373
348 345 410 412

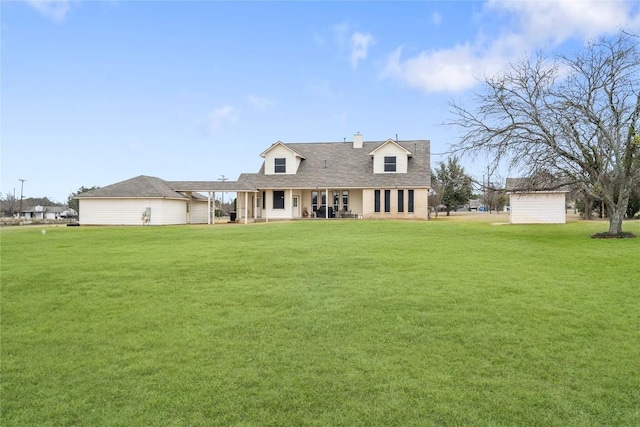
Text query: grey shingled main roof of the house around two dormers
238 140 431 189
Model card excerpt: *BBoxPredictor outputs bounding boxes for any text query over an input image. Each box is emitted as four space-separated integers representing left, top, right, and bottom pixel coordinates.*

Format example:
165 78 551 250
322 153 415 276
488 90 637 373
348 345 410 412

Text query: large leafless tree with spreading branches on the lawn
449 32 640 235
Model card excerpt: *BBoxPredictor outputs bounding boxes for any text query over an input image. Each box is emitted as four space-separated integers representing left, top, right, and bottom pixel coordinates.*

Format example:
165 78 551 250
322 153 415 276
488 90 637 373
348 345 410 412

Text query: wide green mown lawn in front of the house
0 219 640 426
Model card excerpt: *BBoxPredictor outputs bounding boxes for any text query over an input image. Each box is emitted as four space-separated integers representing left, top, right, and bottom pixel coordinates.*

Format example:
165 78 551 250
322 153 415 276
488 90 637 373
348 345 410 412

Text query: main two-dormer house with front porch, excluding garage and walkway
238 133 431 219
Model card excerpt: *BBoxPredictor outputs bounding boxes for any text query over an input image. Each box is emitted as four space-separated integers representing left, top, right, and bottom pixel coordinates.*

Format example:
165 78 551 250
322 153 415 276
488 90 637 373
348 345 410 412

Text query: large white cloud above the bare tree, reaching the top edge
381 0 640 92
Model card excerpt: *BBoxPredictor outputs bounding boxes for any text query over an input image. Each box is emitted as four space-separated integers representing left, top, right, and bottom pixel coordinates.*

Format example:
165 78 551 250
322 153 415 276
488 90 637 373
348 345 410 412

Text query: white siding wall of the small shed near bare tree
509 193 566 224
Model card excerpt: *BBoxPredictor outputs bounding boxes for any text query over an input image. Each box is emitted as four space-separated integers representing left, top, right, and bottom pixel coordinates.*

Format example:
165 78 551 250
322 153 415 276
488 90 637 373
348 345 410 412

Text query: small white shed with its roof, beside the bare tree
505 178 568 224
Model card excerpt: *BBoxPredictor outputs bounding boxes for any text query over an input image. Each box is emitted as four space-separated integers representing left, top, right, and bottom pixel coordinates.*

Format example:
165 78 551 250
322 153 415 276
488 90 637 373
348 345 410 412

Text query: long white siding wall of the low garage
79 198 187 225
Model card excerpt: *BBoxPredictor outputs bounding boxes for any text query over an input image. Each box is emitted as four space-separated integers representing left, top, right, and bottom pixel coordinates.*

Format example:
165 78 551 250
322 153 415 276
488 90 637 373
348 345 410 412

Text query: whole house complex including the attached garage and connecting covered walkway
76 133 431 225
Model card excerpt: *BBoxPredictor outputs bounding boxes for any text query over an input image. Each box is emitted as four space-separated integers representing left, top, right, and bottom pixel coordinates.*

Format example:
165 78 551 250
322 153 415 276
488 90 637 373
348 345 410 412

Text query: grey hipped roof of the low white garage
75 175 189 200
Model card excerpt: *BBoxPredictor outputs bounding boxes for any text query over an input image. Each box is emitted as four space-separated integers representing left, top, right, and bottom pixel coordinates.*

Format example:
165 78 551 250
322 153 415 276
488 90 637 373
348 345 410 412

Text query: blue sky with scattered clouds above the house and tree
0 0 640 201
